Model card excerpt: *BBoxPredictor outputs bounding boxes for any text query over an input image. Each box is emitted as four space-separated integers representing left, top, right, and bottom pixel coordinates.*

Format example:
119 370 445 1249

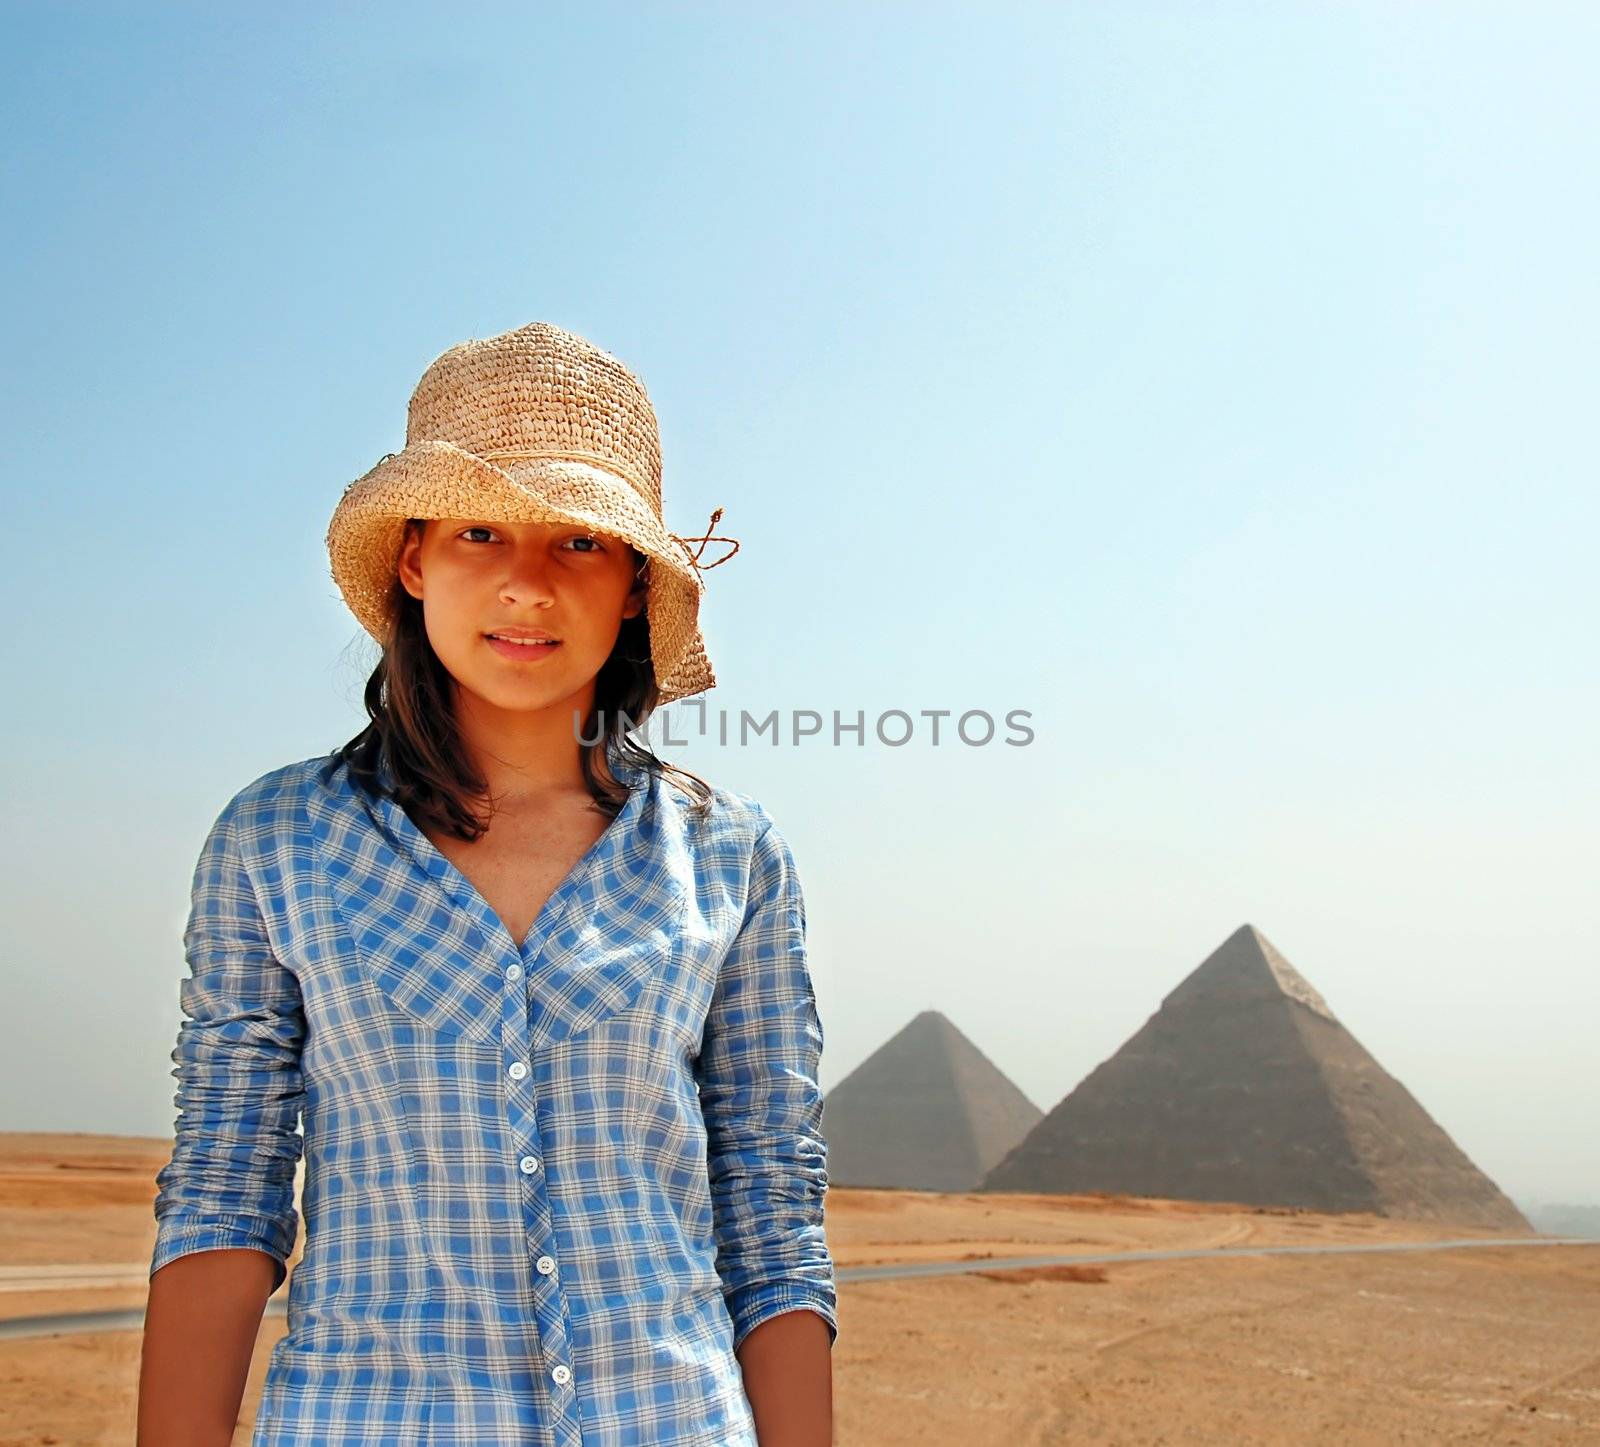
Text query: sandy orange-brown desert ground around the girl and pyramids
0 1135 1600 1447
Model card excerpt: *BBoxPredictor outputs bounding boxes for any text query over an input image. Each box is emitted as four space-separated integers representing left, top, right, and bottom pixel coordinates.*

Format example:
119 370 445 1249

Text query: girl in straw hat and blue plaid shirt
139 322 838 1447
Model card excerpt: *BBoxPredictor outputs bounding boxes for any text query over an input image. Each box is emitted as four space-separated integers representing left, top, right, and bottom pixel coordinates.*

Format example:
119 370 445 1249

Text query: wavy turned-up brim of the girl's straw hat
326 440 717 703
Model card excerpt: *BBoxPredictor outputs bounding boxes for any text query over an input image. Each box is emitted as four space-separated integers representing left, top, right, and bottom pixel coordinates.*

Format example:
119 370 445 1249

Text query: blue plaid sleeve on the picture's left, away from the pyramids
150 797 304 1292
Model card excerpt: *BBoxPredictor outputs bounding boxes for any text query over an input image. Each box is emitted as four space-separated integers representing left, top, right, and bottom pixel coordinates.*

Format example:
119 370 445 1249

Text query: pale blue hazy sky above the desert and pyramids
0 3 1600 1204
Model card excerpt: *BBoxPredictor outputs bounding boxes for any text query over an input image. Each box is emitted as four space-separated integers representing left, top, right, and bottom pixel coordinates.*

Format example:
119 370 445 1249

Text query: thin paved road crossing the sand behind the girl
0 1236 1600 1338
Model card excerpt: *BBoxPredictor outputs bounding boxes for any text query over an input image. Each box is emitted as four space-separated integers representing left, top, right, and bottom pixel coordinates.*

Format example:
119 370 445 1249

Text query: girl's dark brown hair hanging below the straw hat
334 517 712 842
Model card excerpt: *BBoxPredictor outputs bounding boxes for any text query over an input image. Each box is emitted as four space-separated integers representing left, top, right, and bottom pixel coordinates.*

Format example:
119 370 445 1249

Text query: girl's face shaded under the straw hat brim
398 517 645 715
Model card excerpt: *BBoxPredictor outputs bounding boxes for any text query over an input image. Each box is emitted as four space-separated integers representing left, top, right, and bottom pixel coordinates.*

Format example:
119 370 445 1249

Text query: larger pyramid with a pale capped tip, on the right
981 925 1531 1231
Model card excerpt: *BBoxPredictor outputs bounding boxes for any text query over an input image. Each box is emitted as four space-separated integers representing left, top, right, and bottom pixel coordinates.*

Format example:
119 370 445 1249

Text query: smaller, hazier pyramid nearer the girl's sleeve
822 1010 1043 1191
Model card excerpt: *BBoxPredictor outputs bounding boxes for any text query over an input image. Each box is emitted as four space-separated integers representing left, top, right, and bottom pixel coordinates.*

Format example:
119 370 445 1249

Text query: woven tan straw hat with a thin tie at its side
328 322 739 703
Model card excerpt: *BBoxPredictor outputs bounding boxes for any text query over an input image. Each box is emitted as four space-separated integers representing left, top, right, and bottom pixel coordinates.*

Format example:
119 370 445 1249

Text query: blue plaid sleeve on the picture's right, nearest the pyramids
696 812 838 1346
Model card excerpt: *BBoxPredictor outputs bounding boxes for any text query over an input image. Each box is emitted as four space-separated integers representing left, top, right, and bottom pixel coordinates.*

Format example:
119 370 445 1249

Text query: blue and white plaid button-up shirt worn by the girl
150 754 838 1447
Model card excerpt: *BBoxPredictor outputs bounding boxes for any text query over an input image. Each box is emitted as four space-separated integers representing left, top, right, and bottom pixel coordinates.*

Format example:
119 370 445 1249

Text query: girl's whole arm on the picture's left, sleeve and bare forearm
138 800 304 1447
